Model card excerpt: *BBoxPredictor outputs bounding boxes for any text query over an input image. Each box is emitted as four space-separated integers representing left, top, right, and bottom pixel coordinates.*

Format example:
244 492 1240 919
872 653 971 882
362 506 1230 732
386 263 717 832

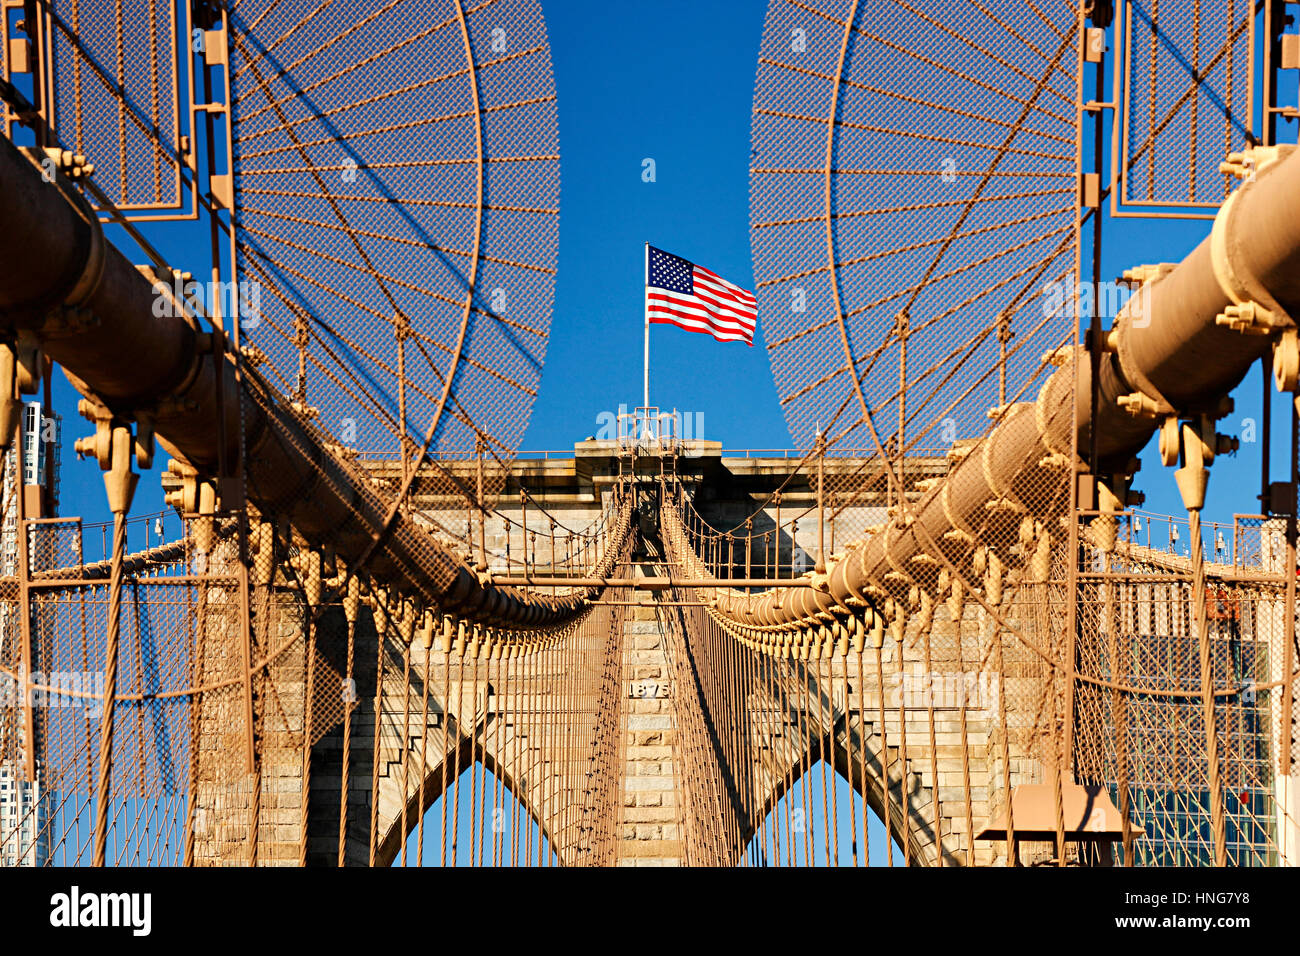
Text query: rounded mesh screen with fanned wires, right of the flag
750 0 1078 449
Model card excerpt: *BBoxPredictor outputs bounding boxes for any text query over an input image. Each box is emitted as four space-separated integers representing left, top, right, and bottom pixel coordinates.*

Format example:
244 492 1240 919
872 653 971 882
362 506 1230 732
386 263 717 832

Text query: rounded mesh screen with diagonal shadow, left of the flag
230 0 559 458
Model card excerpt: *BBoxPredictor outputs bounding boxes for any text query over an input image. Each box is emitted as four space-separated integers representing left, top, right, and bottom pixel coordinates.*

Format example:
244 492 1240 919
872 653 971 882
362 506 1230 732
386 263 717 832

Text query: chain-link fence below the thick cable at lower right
1076 514 1295 866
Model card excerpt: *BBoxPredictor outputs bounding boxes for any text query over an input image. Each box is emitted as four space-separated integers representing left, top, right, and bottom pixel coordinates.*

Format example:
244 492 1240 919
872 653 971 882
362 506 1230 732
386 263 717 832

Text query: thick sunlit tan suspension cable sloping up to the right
696 147 1300 626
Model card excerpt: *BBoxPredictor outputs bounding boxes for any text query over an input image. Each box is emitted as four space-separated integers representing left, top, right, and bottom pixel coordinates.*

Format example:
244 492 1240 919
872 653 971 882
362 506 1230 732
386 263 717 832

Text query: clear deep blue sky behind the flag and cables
45 0 1295 530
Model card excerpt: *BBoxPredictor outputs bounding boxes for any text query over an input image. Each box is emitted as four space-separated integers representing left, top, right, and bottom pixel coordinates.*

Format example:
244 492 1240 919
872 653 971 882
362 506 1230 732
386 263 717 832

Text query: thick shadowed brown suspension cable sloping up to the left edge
0 138 618 626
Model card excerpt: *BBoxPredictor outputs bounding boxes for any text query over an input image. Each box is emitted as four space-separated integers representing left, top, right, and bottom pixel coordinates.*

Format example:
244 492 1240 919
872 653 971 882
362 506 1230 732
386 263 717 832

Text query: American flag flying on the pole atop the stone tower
646 246 758 345
